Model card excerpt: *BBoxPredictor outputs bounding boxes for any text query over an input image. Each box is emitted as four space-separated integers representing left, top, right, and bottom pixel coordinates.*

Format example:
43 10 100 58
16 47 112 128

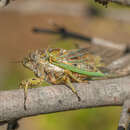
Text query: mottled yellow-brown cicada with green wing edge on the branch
20 48 125 109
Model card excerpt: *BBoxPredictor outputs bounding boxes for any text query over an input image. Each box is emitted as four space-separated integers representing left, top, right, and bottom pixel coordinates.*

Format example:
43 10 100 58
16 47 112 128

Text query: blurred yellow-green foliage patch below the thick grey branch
35 107 120 130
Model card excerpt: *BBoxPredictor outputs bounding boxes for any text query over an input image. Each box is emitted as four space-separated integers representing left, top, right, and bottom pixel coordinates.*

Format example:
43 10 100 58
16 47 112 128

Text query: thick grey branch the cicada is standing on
0 77 130 121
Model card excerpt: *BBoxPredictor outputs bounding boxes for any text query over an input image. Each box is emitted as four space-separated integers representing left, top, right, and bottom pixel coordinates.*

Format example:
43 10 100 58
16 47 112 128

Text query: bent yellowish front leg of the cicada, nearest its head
20 78 44 110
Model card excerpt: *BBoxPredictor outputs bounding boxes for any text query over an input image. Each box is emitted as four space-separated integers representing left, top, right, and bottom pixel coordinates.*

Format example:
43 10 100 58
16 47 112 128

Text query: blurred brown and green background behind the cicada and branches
0 0 130 130
